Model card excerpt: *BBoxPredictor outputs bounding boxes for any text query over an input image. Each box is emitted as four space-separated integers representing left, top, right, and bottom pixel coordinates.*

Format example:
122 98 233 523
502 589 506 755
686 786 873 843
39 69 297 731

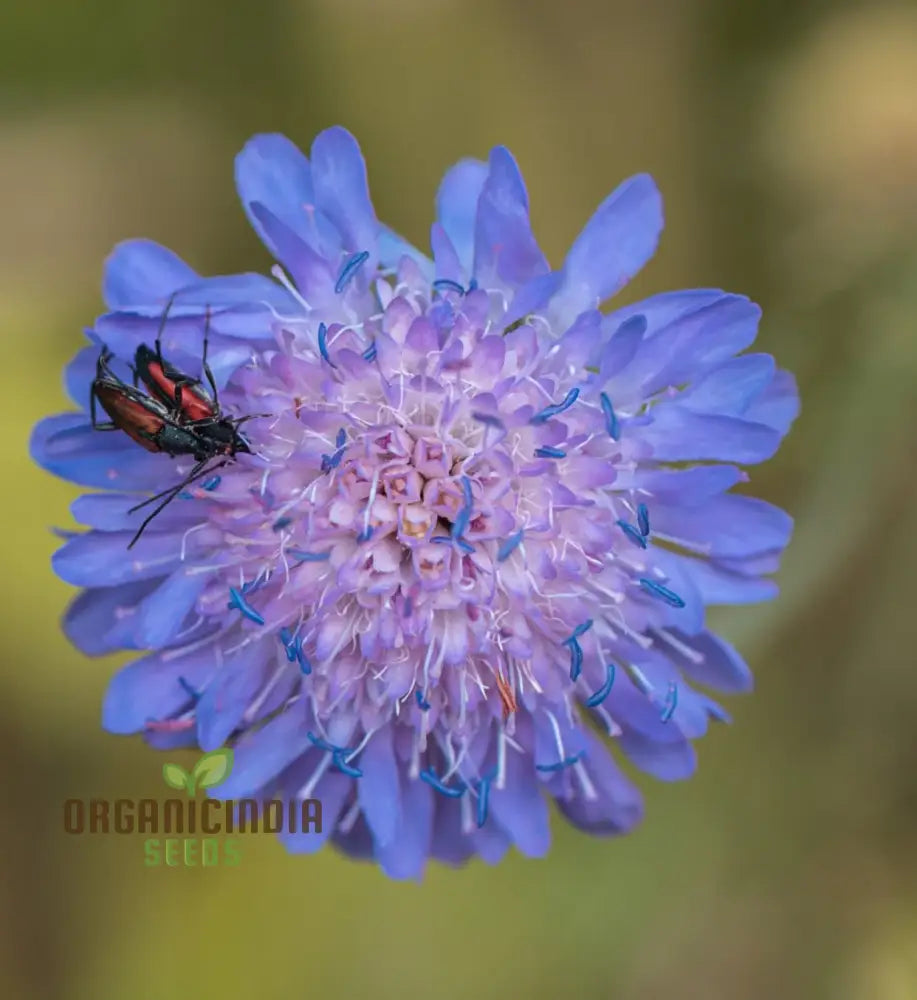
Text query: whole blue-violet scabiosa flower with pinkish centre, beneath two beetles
32 128 797 878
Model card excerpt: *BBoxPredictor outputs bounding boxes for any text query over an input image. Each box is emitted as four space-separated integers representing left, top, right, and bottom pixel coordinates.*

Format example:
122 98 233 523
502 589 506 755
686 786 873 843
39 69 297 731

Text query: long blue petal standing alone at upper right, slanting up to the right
552 174 663 323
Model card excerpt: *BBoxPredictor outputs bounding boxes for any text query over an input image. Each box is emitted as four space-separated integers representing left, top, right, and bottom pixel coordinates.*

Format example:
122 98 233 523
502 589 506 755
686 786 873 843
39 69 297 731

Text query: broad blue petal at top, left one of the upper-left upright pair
235 134 340 260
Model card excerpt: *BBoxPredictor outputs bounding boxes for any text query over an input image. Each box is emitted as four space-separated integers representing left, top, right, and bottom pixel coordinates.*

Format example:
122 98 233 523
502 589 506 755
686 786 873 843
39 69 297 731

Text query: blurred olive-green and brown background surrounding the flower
0 0 917 1000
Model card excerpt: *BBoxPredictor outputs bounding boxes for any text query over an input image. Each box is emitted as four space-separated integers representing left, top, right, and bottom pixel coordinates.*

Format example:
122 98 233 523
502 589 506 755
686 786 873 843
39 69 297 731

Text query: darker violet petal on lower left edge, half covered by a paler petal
63 579 159 656
